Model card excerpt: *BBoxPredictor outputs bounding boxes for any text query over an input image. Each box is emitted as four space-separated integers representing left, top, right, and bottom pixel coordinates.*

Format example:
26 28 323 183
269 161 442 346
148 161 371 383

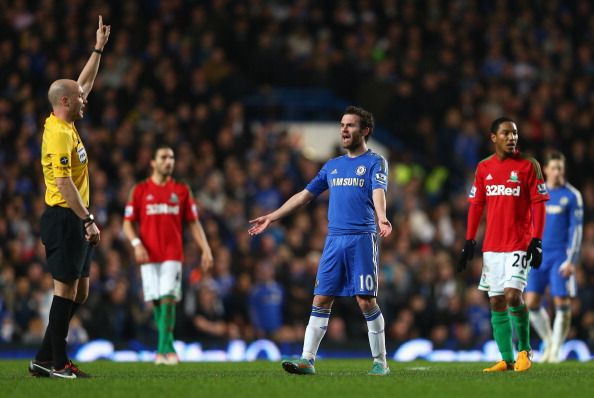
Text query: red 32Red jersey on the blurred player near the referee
124 178 198 263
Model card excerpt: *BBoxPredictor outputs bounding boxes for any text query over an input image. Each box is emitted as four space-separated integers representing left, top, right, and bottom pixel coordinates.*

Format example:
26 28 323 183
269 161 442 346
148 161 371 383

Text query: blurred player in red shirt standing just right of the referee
124 146 213 365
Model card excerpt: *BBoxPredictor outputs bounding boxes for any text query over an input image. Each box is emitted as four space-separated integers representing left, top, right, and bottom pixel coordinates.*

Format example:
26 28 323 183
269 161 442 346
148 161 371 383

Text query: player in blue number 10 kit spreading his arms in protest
248 106 392 376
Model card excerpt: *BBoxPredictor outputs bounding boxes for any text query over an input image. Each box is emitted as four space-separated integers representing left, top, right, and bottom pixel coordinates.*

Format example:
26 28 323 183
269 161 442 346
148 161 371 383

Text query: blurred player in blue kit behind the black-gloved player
526 152 583 363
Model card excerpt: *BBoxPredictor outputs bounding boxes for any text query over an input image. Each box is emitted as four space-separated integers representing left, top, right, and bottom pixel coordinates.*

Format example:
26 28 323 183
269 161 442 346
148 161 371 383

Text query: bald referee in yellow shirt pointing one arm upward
29 15 111 379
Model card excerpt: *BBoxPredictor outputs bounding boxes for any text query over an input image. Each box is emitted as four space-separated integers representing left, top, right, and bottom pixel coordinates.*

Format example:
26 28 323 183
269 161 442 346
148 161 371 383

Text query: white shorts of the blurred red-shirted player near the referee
140 261 182 301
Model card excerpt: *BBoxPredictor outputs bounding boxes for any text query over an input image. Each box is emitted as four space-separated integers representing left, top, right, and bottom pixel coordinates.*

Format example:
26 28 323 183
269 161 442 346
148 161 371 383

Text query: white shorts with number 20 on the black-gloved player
478 251 530 297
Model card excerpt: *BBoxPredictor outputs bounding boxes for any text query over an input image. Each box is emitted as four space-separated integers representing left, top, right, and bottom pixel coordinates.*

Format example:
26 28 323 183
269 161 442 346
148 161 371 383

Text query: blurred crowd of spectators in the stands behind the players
0 0 594 349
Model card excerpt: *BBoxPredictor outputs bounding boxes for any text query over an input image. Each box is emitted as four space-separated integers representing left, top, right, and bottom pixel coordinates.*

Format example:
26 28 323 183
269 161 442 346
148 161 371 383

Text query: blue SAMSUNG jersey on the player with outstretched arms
305 150 388 235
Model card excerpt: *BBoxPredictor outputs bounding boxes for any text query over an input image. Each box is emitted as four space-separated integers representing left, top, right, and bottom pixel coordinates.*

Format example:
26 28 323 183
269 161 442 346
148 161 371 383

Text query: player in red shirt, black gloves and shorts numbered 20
458 117 549 372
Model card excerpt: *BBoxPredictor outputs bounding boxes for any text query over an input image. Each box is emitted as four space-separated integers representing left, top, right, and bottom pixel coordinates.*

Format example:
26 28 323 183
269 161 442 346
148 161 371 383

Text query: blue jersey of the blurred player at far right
542 184 584 264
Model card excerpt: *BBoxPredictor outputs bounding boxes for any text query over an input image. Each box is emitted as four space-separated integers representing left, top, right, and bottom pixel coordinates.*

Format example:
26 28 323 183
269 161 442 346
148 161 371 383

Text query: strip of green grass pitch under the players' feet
0 360 594 398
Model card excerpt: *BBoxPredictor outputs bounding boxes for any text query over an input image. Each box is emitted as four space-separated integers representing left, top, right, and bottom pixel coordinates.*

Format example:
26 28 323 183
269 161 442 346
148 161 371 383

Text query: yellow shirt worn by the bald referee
41 113 89 207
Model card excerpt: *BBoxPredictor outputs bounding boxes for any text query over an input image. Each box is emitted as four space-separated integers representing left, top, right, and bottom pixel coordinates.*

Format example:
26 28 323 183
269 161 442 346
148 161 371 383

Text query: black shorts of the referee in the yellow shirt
41 206 93 282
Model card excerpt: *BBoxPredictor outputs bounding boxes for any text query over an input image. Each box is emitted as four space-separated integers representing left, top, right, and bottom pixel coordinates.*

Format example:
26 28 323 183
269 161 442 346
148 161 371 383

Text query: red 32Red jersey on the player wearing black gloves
468 153 549 252
